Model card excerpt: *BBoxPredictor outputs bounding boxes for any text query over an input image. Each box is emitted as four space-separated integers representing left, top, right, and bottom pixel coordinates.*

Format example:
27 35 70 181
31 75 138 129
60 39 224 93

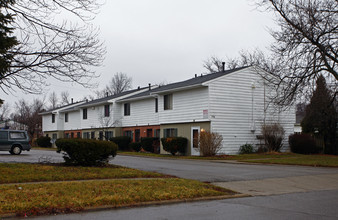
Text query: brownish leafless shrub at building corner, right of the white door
199 131 223 157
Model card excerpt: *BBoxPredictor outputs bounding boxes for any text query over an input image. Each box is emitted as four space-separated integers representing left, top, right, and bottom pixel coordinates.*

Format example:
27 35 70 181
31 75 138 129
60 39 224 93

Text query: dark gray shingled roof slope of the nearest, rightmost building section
121 66 248 101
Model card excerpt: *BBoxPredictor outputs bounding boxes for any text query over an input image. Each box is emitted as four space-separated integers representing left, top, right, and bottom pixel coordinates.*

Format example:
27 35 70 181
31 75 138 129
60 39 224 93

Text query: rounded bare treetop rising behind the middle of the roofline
95 73 132 98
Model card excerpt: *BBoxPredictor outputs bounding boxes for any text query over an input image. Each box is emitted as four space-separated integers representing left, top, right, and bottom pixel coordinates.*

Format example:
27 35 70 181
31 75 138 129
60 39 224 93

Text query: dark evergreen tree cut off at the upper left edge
0 0 18 78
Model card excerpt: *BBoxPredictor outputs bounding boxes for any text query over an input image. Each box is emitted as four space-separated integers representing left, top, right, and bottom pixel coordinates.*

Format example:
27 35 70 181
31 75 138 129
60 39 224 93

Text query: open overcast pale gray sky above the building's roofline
2 0 274 109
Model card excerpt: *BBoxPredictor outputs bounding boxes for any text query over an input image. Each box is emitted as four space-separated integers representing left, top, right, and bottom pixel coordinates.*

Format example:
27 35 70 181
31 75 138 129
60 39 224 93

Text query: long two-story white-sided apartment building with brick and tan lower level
39 66 295 155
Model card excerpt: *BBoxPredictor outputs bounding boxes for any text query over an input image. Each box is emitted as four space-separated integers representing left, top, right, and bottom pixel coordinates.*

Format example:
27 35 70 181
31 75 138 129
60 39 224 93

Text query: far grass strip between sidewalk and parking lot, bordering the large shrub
0 163 165 184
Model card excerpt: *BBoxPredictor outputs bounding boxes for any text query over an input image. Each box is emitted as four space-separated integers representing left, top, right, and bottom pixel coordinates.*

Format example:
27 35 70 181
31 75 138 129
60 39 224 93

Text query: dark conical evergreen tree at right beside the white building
301 76 338 154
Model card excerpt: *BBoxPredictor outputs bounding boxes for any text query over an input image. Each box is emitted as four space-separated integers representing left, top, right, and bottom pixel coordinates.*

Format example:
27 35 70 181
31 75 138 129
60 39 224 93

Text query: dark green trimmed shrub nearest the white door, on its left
161 137 188 155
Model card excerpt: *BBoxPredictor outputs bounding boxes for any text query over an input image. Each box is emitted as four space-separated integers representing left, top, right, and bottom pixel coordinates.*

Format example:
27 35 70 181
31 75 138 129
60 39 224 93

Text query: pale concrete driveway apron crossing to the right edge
212 174 338 196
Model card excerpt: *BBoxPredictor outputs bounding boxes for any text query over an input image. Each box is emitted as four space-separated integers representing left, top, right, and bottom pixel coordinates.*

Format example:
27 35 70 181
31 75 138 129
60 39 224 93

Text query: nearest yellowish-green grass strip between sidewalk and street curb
0 178 235 216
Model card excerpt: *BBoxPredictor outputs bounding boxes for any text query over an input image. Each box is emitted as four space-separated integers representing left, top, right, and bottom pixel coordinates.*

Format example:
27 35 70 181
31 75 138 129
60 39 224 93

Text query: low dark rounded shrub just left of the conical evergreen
289 134 320 154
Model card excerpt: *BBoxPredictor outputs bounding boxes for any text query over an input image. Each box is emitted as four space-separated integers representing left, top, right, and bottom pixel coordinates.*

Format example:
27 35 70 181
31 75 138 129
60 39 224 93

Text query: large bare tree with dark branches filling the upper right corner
258 0 338 104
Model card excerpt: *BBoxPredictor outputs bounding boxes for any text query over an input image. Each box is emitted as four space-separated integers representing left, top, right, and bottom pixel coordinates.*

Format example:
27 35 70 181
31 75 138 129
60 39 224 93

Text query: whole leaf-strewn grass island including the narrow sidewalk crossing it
0 163 236 218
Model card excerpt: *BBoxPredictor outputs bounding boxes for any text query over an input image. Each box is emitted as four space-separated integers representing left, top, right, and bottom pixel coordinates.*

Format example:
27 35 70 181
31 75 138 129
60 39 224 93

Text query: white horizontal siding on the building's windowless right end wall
209 68 294 154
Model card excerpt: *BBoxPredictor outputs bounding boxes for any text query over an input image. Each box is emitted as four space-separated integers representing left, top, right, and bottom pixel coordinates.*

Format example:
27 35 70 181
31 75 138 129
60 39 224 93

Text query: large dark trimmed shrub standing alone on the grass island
56 139 117 166
